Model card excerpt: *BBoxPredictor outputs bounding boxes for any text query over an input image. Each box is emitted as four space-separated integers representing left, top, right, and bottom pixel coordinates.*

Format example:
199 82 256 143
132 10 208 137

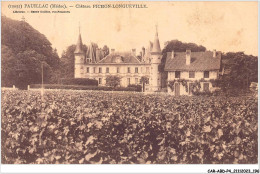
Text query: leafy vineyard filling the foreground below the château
1 90 258 164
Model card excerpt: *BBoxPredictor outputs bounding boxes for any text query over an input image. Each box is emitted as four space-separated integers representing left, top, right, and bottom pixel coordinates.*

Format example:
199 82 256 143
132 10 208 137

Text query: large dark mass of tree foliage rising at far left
1 16 59 88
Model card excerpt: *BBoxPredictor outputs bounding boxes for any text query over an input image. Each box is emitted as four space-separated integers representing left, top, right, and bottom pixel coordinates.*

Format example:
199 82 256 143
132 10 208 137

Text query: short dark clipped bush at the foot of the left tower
61 78 98 86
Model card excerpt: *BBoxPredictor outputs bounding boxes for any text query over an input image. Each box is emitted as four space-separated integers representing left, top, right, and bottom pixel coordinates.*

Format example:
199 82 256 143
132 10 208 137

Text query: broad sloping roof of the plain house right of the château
164 51 221 71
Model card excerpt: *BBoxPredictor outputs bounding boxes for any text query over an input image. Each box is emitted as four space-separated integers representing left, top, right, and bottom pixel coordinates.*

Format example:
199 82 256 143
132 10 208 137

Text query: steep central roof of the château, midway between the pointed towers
98 52 141 64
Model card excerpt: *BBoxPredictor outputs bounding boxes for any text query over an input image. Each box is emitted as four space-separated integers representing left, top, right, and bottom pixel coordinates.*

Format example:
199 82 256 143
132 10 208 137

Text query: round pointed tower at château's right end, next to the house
151 25 162 91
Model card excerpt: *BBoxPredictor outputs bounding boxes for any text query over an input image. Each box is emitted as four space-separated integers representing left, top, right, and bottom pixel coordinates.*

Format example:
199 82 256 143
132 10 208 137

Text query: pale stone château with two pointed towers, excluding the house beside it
74 26 162 91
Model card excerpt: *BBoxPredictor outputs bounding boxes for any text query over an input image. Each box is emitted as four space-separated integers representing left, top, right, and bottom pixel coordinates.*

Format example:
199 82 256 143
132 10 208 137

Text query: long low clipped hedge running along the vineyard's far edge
30 84 140 92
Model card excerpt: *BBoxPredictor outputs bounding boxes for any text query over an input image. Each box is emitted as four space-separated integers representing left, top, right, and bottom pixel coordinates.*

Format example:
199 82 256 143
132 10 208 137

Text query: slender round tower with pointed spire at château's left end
74 28 85 78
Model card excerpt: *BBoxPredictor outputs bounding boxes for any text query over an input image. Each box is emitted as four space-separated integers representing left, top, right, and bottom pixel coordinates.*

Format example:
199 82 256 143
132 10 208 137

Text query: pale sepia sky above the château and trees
2 1 258 56
